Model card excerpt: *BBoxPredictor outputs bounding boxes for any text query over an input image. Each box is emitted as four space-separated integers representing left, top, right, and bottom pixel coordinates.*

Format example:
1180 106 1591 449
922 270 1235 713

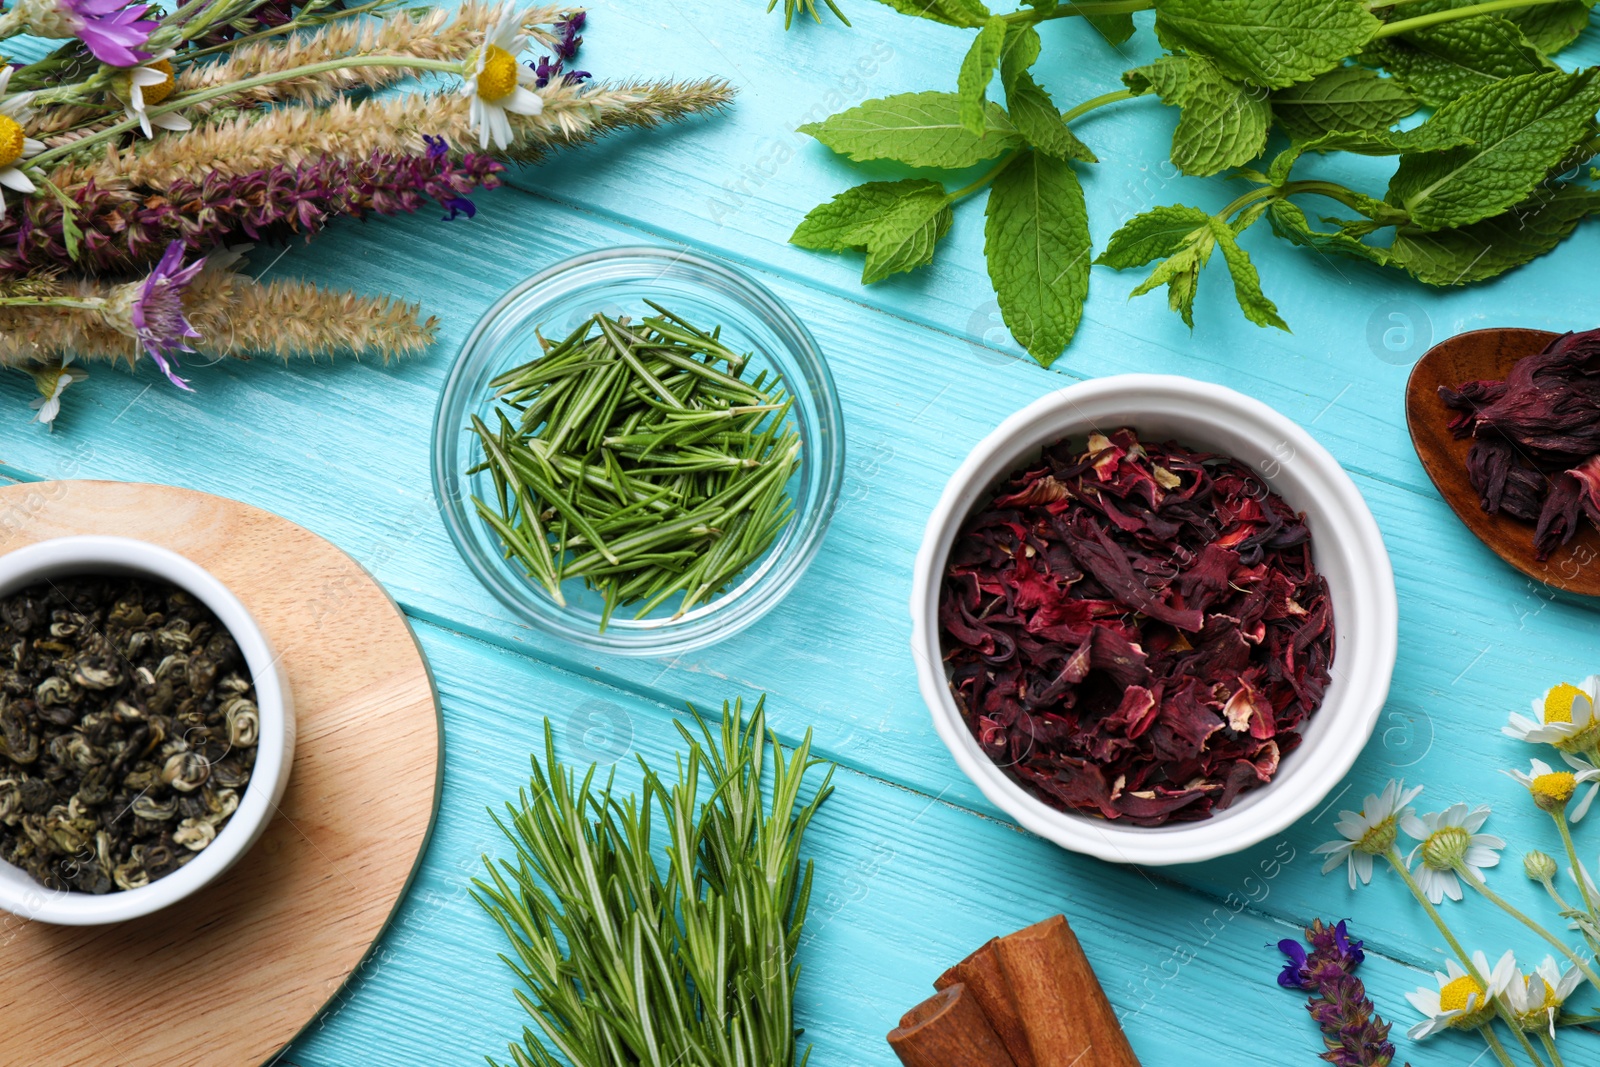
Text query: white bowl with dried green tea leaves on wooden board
0 536 294 926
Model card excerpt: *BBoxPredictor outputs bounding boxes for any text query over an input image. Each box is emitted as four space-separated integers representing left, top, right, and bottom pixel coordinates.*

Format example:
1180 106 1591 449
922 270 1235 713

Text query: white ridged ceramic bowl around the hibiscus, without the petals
910 374 1398 864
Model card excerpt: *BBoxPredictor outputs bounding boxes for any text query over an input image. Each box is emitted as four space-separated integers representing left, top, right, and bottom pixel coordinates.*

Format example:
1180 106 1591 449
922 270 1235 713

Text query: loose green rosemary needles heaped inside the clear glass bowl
470 304 800 630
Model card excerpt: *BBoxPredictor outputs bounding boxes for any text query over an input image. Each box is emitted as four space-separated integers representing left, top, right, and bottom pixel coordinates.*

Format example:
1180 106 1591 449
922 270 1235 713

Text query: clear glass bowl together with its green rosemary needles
434 248 843 654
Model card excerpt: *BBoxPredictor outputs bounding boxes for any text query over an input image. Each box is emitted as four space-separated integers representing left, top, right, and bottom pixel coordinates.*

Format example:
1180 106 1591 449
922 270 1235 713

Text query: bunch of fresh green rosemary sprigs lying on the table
474 699 834 1067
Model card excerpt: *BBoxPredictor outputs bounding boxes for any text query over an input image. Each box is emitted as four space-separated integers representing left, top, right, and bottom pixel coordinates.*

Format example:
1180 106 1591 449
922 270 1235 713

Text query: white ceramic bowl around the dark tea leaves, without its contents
0 536 294 926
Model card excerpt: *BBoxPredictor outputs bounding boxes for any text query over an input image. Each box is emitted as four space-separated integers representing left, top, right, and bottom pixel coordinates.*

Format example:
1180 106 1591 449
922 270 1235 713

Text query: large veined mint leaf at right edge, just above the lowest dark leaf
1386 69 1600 230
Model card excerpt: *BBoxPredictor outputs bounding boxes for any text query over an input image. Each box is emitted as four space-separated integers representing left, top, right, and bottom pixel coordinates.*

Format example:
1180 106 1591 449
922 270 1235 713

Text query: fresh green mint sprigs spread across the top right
792 0 1600 365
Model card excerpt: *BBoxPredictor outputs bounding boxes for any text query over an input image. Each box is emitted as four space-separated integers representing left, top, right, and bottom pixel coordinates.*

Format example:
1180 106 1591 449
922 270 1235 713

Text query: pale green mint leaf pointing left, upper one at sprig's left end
800 93 1022 170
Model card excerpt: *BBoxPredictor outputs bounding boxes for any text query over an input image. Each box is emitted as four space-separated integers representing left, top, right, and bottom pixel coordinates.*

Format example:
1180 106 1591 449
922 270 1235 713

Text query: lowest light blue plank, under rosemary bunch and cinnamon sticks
275 625 1574 1067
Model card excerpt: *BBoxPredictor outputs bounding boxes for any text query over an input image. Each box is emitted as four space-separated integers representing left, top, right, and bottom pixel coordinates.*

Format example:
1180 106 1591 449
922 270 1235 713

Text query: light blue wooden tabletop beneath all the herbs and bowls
0 0 1600 1067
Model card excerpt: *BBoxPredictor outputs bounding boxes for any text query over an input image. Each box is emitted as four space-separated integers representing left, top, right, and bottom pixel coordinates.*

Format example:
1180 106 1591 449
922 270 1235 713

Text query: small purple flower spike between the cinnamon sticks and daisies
1278 918 1395 1067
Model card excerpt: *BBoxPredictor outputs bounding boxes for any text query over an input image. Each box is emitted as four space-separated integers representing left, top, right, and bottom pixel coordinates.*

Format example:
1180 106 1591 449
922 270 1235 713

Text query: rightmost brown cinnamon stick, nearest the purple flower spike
995 915 1139 1067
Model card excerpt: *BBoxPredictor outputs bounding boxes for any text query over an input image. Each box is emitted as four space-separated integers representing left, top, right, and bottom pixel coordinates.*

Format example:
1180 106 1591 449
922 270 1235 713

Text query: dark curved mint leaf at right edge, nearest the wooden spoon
1389 186 1600 285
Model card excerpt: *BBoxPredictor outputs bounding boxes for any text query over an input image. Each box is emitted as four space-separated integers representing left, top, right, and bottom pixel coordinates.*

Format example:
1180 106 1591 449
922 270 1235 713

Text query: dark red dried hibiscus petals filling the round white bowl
939 428 1337 825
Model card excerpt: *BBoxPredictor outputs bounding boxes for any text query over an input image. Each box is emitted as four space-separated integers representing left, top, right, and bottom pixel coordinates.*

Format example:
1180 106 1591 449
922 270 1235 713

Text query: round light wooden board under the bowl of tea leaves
0 482 443 1067
